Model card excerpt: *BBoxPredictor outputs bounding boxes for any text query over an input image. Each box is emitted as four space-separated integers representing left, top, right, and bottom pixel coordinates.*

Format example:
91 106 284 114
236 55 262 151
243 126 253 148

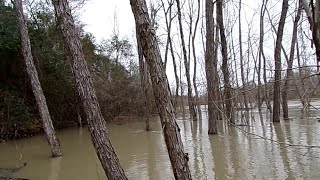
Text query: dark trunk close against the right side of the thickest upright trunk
216 0 234 123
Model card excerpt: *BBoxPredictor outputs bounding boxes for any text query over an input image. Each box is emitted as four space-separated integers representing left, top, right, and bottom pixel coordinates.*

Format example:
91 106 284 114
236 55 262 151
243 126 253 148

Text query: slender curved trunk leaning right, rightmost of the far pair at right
282 0 302 120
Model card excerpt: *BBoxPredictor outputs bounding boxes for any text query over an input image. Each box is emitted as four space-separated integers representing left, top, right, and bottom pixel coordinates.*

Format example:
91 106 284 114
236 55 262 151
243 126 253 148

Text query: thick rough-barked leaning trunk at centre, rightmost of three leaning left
130 0 191 179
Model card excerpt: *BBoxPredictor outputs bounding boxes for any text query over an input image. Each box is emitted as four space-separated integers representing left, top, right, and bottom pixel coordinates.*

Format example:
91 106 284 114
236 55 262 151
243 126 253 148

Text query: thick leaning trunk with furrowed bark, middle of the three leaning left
52 0 127 180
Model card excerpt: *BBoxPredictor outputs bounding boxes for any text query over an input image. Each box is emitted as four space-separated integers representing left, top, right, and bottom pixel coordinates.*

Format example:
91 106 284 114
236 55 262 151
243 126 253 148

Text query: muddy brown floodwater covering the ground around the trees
0 101 320 180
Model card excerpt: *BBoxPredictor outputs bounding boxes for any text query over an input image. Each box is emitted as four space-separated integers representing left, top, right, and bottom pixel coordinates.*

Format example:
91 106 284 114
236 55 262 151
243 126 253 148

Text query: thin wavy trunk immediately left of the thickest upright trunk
192 0 202 120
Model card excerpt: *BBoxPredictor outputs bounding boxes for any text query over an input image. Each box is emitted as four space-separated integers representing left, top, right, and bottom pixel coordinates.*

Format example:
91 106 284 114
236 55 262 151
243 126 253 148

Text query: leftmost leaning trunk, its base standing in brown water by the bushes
14 0 62 157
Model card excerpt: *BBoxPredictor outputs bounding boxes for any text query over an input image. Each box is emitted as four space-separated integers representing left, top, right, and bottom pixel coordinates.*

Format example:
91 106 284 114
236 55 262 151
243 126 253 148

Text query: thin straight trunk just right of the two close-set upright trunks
239 0 249 114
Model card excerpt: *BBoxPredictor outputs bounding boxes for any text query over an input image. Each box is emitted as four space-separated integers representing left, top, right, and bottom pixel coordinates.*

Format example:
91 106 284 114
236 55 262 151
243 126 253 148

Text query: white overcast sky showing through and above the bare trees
80 0 318 93
